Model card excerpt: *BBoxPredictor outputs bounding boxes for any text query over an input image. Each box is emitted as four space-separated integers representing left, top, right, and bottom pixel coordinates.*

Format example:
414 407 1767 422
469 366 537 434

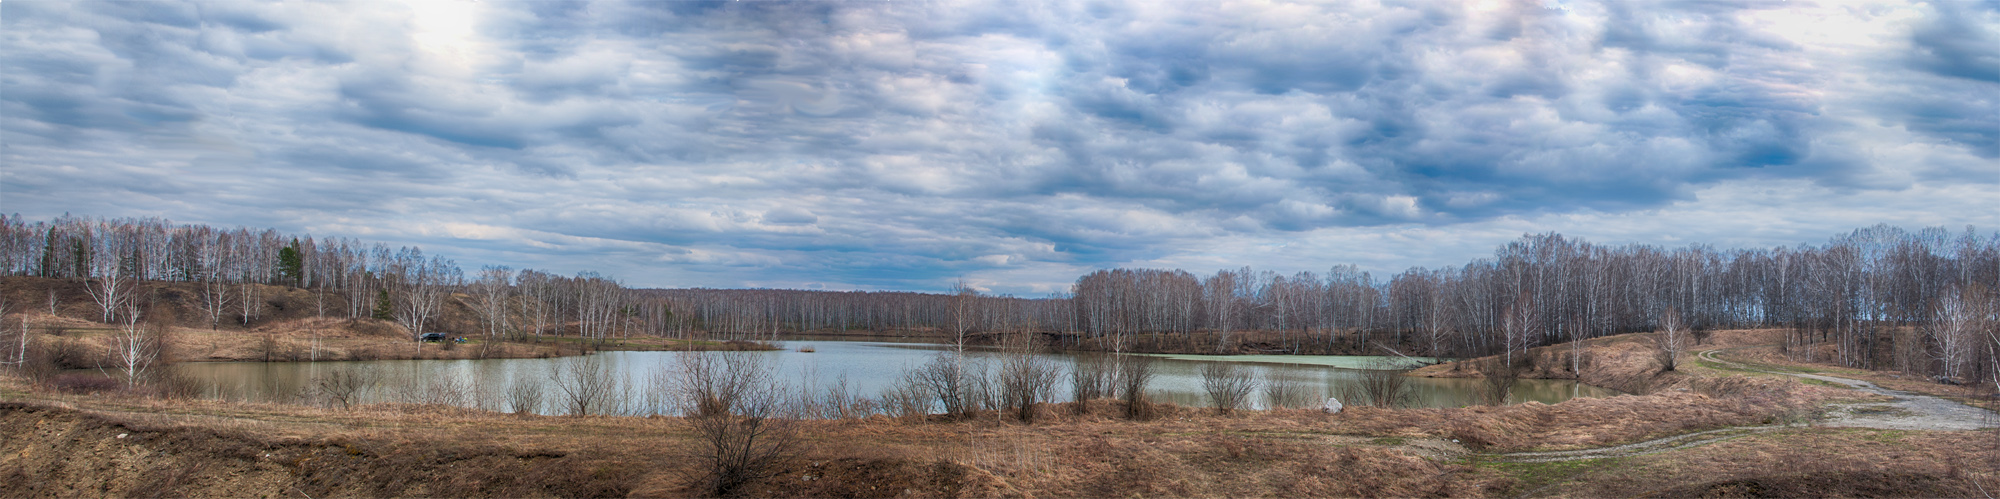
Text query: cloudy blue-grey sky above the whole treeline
0 0 2000 295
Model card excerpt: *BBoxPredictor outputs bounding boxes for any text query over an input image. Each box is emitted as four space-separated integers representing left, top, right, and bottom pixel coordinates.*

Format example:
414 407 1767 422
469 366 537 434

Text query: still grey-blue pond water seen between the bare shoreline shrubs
174 341 1618 411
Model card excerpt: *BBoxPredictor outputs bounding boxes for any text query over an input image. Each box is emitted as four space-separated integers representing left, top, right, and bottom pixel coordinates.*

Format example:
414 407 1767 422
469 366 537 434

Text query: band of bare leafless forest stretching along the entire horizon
0 216 2000 381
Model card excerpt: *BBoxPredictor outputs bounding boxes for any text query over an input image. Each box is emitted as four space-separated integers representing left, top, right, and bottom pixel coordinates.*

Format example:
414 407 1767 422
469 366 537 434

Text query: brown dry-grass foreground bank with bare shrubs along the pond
0 325 2000 497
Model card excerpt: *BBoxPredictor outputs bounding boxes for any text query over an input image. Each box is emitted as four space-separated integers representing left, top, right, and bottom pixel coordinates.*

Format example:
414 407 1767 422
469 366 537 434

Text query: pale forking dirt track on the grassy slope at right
1484 349 2000 463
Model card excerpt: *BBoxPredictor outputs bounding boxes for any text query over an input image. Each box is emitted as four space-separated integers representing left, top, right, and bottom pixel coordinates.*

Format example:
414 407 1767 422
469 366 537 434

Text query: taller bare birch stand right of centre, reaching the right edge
1068 226 2000 379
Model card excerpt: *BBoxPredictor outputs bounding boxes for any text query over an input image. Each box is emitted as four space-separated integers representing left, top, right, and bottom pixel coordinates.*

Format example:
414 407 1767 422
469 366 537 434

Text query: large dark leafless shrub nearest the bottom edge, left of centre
676 351 800 497
